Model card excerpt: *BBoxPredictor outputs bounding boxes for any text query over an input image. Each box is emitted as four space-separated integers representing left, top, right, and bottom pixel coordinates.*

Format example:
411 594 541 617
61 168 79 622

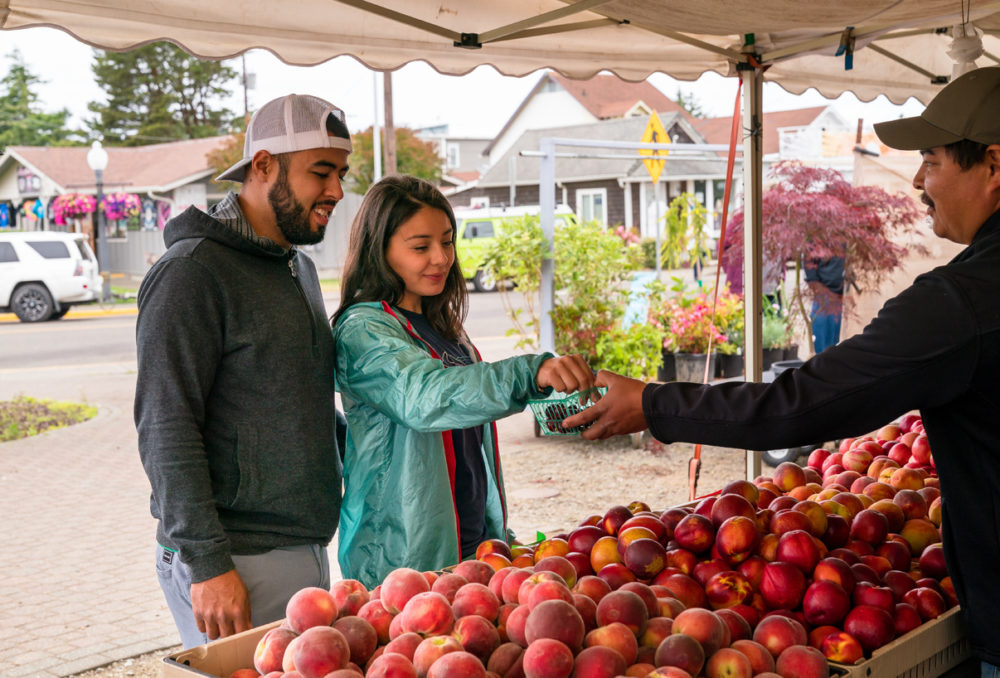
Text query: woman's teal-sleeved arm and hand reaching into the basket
335 309 593 431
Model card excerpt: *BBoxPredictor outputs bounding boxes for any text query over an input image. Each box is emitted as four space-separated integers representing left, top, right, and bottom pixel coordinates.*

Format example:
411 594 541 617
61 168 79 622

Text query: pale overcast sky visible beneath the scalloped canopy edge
0 28 923 138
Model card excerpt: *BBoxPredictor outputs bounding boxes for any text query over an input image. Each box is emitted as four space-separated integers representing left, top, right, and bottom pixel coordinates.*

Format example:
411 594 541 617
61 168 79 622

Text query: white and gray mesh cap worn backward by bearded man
215 94 351 182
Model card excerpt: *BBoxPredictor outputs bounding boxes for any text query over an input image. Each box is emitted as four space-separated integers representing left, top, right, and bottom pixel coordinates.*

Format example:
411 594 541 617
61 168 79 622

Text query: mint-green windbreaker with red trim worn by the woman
333 302 552 589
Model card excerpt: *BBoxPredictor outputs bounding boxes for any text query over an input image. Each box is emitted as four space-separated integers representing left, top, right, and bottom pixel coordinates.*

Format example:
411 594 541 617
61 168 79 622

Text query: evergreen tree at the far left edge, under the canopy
0 49 70 152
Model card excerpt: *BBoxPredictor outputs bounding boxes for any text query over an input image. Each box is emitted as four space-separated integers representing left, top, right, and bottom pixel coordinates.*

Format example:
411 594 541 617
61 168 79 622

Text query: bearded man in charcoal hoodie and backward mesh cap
135 95 351 647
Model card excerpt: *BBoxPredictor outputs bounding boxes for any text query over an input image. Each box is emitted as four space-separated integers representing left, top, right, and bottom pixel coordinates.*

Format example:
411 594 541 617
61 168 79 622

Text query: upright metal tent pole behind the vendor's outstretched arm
742 68 764 481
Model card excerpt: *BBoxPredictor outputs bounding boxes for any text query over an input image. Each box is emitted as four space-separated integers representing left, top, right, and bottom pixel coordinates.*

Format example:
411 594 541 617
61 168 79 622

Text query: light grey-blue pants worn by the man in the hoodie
156 544 330 648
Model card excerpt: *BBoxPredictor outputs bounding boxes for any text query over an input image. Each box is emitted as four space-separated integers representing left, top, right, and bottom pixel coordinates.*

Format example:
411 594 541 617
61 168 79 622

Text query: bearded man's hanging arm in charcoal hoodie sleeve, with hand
135 258 250 637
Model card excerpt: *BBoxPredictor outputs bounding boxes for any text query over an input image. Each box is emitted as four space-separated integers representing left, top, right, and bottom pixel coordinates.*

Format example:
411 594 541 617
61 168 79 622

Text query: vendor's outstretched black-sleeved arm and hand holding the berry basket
565 277 979 449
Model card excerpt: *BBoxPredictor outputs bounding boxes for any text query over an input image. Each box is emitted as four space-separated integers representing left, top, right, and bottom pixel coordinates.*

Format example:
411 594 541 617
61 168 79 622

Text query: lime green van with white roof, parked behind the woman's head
455 205 576 292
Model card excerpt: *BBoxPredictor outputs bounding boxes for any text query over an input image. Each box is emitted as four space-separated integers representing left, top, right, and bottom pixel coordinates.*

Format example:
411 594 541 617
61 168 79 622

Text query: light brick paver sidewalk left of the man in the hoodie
0 364 178 678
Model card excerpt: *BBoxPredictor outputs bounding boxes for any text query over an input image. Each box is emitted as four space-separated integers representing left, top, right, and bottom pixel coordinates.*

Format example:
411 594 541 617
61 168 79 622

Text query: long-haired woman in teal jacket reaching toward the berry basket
332 176 593 587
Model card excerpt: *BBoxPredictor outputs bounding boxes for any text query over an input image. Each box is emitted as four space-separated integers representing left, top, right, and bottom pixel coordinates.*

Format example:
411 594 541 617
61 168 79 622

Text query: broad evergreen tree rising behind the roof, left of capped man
87 42 237 146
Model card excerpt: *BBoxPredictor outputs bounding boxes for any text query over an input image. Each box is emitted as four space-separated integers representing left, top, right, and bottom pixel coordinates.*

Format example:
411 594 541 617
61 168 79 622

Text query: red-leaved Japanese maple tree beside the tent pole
720 161 924 352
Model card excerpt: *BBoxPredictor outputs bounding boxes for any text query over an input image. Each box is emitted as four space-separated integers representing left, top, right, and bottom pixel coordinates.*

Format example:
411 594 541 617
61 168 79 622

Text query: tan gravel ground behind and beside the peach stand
70 437 752 678
